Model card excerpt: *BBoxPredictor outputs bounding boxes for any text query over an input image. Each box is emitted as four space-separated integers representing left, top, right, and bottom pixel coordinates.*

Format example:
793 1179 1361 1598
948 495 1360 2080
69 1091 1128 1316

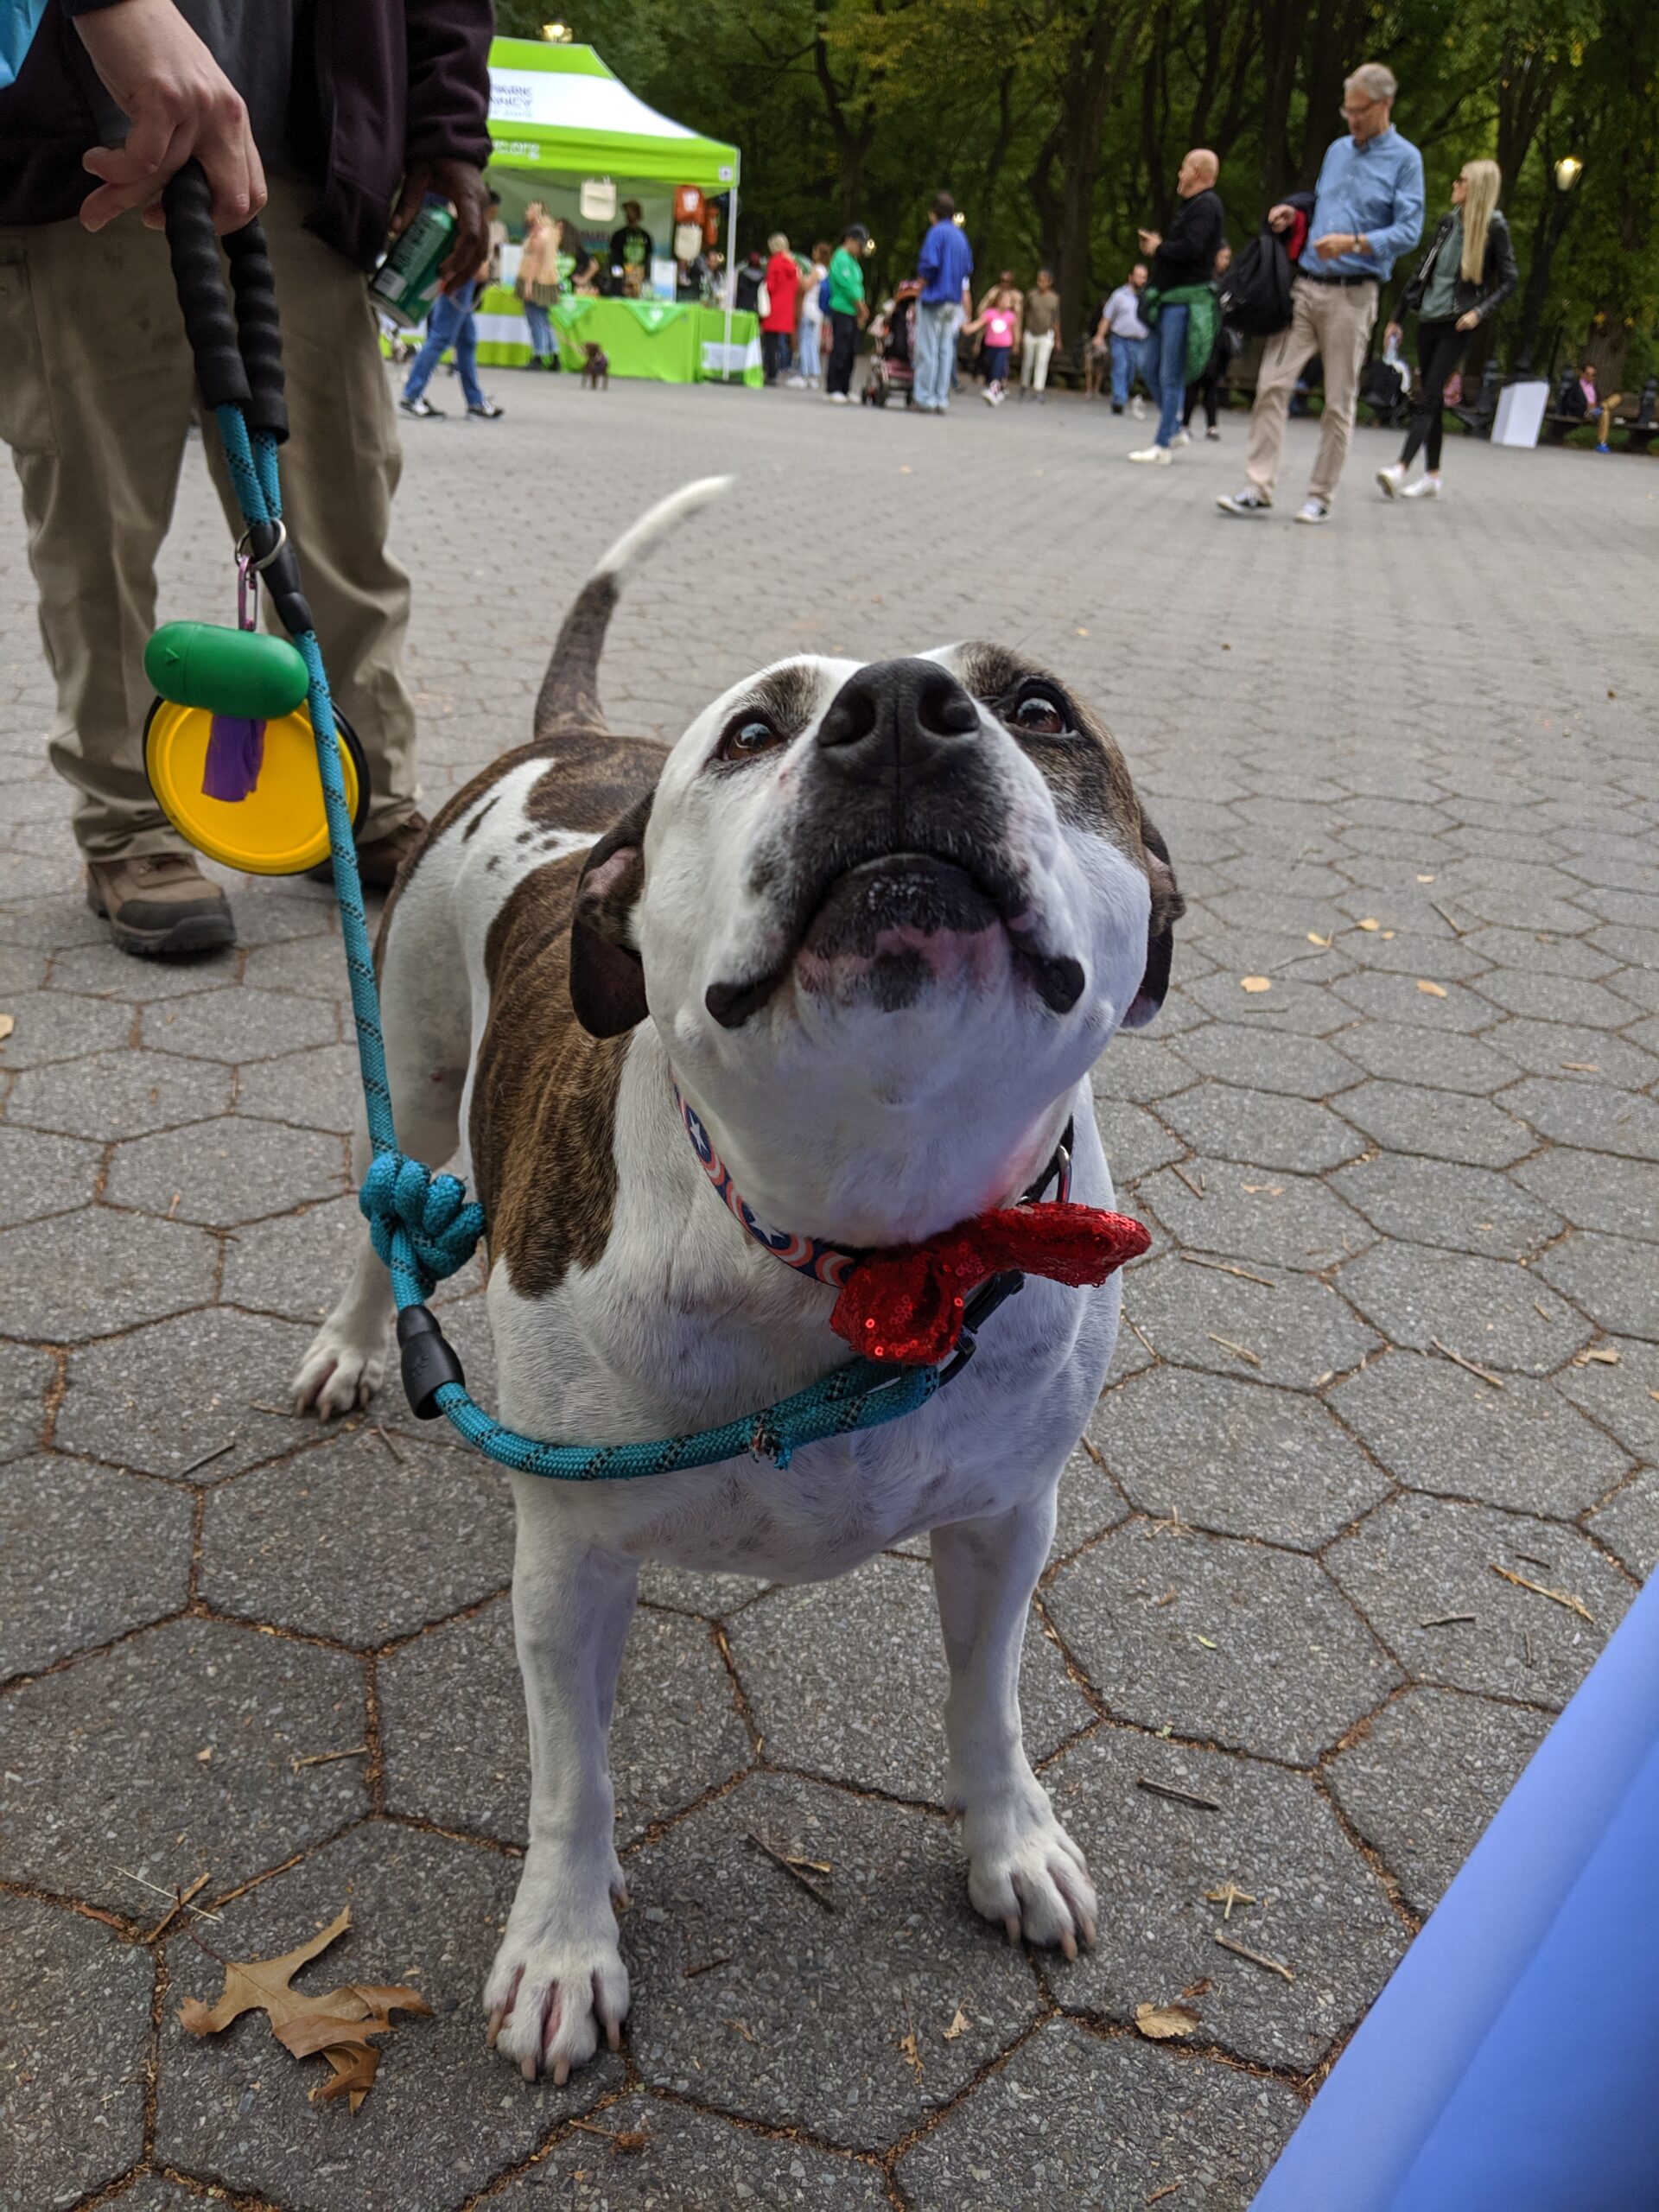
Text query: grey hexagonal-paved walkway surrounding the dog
0 376 1659 2212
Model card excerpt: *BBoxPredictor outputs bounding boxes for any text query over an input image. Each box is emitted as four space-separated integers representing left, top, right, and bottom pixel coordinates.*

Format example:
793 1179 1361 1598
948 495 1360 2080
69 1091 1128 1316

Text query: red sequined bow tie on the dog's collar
830 1205 1153 1367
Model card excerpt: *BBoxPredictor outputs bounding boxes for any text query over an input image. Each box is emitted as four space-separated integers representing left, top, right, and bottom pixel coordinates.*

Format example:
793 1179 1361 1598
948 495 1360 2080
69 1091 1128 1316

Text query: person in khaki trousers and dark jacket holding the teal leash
0 0 493 957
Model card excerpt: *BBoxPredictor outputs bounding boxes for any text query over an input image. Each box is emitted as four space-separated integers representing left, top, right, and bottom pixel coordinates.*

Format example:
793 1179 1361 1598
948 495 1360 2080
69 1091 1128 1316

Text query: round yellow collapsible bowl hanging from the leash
143 699 370 876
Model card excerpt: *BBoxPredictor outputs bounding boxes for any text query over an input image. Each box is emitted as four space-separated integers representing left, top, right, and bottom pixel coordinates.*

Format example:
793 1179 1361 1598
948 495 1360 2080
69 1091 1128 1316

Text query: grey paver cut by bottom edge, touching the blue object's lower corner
898 2019 1303 2212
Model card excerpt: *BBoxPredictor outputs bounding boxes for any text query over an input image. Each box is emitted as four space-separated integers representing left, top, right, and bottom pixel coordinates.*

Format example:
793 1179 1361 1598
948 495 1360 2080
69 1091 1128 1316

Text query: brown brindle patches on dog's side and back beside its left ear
469 732 664 1299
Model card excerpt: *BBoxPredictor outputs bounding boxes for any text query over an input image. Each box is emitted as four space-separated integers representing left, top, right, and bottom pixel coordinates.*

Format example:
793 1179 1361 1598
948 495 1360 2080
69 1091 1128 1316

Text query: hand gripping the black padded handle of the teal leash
75 0 265 232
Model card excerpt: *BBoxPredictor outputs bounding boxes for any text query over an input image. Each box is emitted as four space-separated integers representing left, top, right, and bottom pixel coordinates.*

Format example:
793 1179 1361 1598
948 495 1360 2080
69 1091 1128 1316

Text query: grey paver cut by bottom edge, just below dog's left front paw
480 2094 892 2212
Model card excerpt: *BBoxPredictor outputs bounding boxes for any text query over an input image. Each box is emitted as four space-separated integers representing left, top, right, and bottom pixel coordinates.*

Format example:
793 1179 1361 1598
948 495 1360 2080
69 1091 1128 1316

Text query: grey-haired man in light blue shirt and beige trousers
1217 62 1422 522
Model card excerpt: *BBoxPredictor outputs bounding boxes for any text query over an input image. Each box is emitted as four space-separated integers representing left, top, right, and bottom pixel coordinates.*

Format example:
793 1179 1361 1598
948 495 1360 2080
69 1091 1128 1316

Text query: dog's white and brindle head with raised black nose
570 644 1181 1234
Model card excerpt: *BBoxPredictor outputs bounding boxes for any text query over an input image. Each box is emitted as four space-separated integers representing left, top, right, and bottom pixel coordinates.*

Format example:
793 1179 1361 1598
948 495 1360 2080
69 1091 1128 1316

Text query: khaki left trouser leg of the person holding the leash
0 217 194 861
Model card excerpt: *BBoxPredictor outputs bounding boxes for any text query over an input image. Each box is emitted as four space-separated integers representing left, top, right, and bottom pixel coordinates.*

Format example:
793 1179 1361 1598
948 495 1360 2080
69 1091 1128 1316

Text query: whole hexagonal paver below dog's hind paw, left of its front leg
199 1429 513 1648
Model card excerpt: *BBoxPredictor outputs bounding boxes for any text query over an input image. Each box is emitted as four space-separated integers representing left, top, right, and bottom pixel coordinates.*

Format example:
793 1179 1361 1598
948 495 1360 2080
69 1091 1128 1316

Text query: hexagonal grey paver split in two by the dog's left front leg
378 1597 752 1847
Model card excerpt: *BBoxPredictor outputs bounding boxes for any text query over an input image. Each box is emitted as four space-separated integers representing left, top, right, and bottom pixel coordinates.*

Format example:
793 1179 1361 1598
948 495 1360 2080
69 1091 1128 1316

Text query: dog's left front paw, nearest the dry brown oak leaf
485 1904 628 2084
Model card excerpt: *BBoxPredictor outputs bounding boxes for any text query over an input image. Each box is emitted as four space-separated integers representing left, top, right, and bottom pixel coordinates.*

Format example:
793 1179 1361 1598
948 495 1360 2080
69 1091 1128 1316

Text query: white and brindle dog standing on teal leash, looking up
294 478 1181 2082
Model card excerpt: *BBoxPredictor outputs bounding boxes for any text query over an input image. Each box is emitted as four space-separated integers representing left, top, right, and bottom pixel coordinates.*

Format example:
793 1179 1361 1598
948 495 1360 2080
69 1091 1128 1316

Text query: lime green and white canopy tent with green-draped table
478 38 761 383
